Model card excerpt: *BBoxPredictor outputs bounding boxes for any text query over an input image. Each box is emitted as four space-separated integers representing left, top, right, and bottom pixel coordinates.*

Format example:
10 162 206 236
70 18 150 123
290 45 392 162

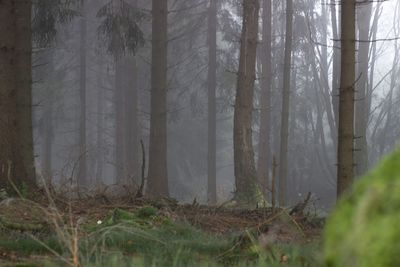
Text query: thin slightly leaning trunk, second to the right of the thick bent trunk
279 0 293 206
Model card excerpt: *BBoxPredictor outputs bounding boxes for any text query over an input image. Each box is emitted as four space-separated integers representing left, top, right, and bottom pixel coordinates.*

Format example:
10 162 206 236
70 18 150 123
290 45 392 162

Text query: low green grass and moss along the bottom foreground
0 206 320 267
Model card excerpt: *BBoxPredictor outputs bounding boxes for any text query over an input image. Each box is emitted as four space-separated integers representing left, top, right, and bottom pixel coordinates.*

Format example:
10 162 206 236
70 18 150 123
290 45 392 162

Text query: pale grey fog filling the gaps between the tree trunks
32 0 400 209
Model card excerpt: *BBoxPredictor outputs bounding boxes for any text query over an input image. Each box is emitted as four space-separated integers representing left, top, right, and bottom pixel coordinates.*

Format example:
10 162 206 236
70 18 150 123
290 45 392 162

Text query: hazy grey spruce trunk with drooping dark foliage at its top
97 0 145 186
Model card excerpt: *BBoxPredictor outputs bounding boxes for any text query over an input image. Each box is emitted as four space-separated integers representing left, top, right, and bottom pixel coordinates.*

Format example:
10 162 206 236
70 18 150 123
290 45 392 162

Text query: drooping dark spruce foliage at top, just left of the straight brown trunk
97 0 145 58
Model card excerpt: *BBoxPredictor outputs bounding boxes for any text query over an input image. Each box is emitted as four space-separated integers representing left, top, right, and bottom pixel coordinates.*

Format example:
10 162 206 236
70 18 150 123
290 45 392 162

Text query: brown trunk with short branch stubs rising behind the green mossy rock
337 0 356 196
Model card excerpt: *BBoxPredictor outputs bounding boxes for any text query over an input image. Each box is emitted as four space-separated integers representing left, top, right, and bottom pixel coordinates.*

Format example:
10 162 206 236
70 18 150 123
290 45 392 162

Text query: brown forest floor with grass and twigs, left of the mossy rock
0 195 324 267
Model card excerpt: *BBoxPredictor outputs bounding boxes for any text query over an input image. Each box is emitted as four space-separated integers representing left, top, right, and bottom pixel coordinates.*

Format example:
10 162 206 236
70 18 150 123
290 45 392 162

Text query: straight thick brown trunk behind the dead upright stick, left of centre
147 0 169 197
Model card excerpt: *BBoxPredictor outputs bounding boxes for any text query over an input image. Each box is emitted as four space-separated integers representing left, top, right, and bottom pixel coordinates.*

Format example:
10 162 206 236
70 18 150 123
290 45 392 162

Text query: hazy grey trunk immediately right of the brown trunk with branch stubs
354 2 372 179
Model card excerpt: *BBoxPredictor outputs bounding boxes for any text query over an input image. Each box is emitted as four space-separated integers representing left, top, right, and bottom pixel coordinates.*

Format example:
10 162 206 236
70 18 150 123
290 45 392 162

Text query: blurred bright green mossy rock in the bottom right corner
324 150 400 267
